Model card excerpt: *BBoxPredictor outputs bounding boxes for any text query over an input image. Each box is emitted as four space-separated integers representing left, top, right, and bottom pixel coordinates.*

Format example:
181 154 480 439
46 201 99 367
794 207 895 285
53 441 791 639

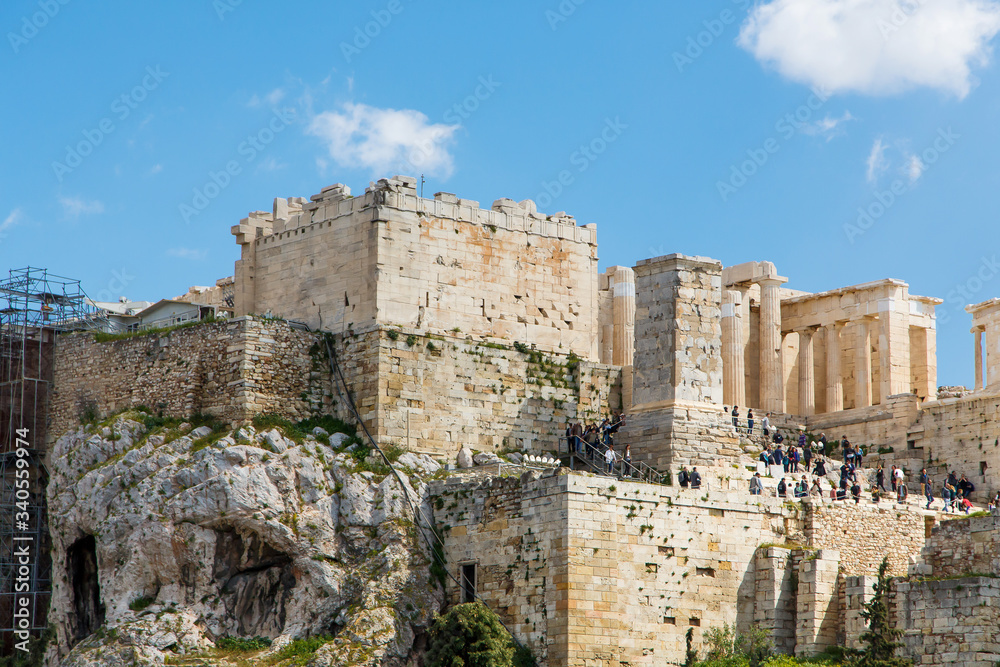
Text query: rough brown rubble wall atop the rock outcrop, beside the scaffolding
50 317 342 444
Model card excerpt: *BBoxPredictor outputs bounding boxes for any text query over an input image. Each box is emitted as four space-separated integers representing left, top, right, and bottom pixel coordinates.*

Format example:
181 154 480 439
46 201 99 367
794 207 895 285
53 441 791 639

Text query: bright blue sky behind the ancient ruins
0 0 1000 385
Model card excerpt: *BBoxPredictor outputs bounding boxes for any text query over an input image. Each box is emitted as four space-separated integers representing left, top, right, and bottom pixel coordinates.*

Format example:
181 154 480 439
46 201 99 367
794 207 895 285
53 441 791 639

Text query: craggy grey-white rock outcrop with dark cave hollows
47 414 443 667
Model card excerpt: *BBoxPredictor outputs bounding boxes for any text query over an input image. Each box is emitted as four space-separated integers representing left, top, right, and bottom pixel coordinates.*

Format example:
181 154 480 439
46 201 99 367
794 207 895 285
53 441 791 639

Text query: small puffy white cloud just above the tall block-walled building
308 102 459 178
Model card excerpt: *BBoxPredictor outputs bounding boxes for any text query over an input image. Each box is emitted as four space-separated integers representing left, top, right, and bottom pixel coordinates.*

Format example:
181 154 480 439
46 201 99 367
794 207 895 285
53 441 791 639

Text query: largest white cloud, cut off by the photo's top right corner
738 0 1000 98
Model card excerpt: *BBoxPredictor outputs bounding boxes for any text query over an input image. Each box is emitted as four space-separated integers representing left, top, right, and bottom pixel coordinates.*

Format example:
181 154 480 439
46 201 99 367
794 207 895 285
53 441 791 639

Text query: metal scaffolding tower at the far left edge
0 267 107 655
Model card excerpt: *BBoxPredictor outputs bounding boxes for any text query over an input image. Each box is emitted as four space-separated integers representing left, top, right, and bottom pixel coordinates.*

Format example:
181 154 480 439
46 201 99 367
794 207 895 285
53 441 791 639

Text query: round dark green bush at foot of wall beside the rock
426 602 534 667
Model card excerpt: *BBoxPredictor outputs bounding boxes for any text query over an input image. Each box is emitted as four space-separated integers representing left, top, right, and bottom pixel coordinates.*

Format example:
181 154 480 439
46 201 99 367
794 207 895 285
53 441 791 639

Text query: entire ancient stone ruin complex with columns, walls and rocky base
6 176 1000 667
